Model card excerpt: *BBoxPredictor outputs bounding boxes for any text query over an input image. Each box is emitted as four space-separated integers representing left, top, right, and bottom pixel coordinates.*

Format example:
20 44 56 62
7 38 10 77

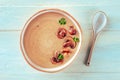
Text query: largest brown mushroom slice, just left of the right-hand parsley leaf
63 36 76 49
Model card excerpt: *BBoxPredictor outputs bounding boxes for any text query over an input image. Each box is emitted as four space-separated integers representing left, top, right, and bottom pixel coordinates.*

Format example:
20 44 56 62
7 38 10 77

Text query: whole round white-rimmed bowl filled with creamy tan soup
20 9 82 72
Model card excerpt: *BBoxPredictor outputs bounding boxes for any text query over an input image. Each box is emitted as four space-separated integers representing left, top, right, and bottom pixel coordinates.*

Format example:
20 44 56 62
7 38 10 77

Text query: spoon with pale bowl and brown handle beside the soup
86 11 107 66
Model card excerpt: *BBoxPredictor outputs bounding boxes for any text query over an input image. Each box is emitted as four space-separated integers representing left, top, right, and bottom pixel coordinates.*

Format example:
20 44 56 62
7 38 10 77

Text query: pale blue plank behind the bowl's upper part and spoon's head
0 6 120 30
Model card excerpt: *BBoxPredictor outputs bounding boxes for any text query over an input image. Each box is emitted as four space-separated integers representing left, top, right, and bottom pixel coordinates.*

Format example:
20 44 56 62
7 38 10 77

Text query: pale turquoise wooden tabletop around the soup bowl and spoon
0 0 120 80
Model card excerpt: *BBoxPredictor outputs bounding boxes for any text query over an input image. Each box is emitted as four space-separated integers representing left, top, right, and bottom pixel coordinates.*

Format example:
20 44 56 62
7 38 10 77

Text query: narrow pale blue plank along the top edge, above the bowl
0 0 119 6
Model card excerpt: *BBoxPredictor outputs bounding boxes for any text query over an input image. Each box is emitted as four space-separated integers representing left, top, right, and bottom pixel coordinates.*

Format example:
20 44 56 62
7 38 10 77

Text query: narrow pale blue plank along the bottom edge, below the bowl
0 73 120 80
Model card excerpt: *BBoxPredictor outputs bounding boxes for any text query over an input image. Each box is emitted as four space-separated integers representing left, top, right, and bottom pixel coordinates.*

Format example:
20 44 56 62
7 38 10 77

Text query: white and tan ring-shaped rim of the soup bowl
20 8 82 73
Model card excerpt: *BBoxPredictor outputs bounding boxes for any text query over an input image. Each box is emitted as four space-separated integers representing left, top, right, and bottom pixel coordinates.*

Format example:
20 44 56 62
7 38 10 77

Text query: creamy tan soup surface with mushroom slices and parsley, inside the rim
23 12 80 68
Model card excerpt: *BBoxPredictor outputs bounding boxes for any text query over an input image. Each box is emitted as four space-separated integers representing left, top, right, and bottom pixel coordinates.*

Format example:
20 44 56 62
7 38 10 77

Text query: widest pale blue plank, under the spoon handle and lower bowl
0 30 120 74
